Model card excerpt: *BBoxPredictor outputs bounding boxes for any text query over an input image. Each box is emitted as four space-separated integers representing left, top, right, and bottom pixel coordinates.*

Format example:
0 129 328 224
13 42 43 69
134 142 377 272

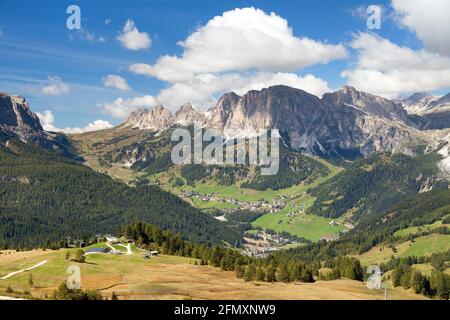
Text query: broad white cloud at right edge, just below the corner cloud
342 33 450 97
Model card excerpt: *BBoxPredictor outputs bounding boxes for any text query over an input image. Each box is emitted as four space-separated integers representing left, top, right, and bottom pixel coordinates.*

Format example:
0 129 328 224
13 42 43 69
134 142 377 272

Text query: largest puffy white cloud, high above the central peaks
131 8 347 81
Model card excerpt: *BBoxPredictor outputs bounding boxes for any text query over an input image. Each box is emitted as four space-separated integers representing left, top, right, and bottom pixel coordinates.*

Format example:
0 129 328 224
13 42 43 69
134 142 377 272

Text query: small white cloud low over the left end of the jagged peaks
98 95 157 119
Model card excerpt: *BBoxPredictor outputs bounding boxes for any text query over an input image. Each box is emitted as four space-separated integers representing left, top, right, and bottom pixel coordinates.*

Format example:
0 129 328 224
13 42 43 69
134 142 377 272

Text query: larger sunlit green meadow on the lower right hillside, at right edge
356 234 450 266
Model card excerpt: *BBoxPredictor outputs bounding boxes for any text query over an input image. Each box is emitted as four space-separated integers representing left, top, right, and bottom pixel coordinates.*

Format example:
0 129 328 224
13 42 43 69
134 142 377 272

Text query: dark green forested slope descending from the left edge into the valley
0 140 240 248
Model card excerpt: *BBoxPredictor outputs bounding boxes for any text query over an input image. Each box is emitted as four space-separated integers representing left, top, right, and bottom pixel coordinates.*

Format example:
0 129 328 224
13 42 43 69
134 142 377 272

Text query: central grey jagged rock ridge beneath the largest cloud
124 85 429 159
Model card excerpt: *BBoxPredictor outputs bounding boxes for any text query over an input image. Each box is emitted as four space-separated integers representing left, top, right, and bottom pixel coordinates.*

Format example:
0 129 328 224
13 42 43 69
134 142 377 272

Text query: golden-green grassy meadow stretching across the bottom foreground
0 250 425 300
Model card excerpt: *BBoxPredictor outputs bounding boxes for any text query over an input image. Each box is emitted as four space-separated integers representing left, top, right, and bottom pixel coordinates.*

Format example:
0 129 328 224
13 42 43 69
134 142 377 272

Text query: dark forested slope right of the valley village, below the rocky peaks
309 153 448 221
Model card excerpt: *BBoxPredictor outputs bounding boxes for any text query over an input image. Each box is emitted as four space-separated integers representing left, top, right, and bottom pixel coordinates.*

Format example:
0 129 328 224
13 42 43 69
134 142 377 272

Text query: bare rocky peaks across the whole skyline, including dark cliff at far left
0 85 450 170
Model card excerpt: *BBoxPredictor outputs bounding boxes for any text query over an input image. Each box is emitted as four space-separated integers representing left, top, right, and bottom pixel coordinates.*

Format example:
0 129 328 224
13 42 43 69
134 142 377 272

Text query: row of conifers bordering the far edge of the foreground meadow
122 223 363 282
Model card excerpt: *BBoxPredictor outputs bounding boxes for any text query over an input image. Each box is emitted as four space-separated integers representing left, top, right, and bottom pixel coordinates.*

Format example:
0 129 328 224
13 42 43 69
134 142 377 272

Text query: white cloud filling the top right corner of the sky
392 0 450 55
